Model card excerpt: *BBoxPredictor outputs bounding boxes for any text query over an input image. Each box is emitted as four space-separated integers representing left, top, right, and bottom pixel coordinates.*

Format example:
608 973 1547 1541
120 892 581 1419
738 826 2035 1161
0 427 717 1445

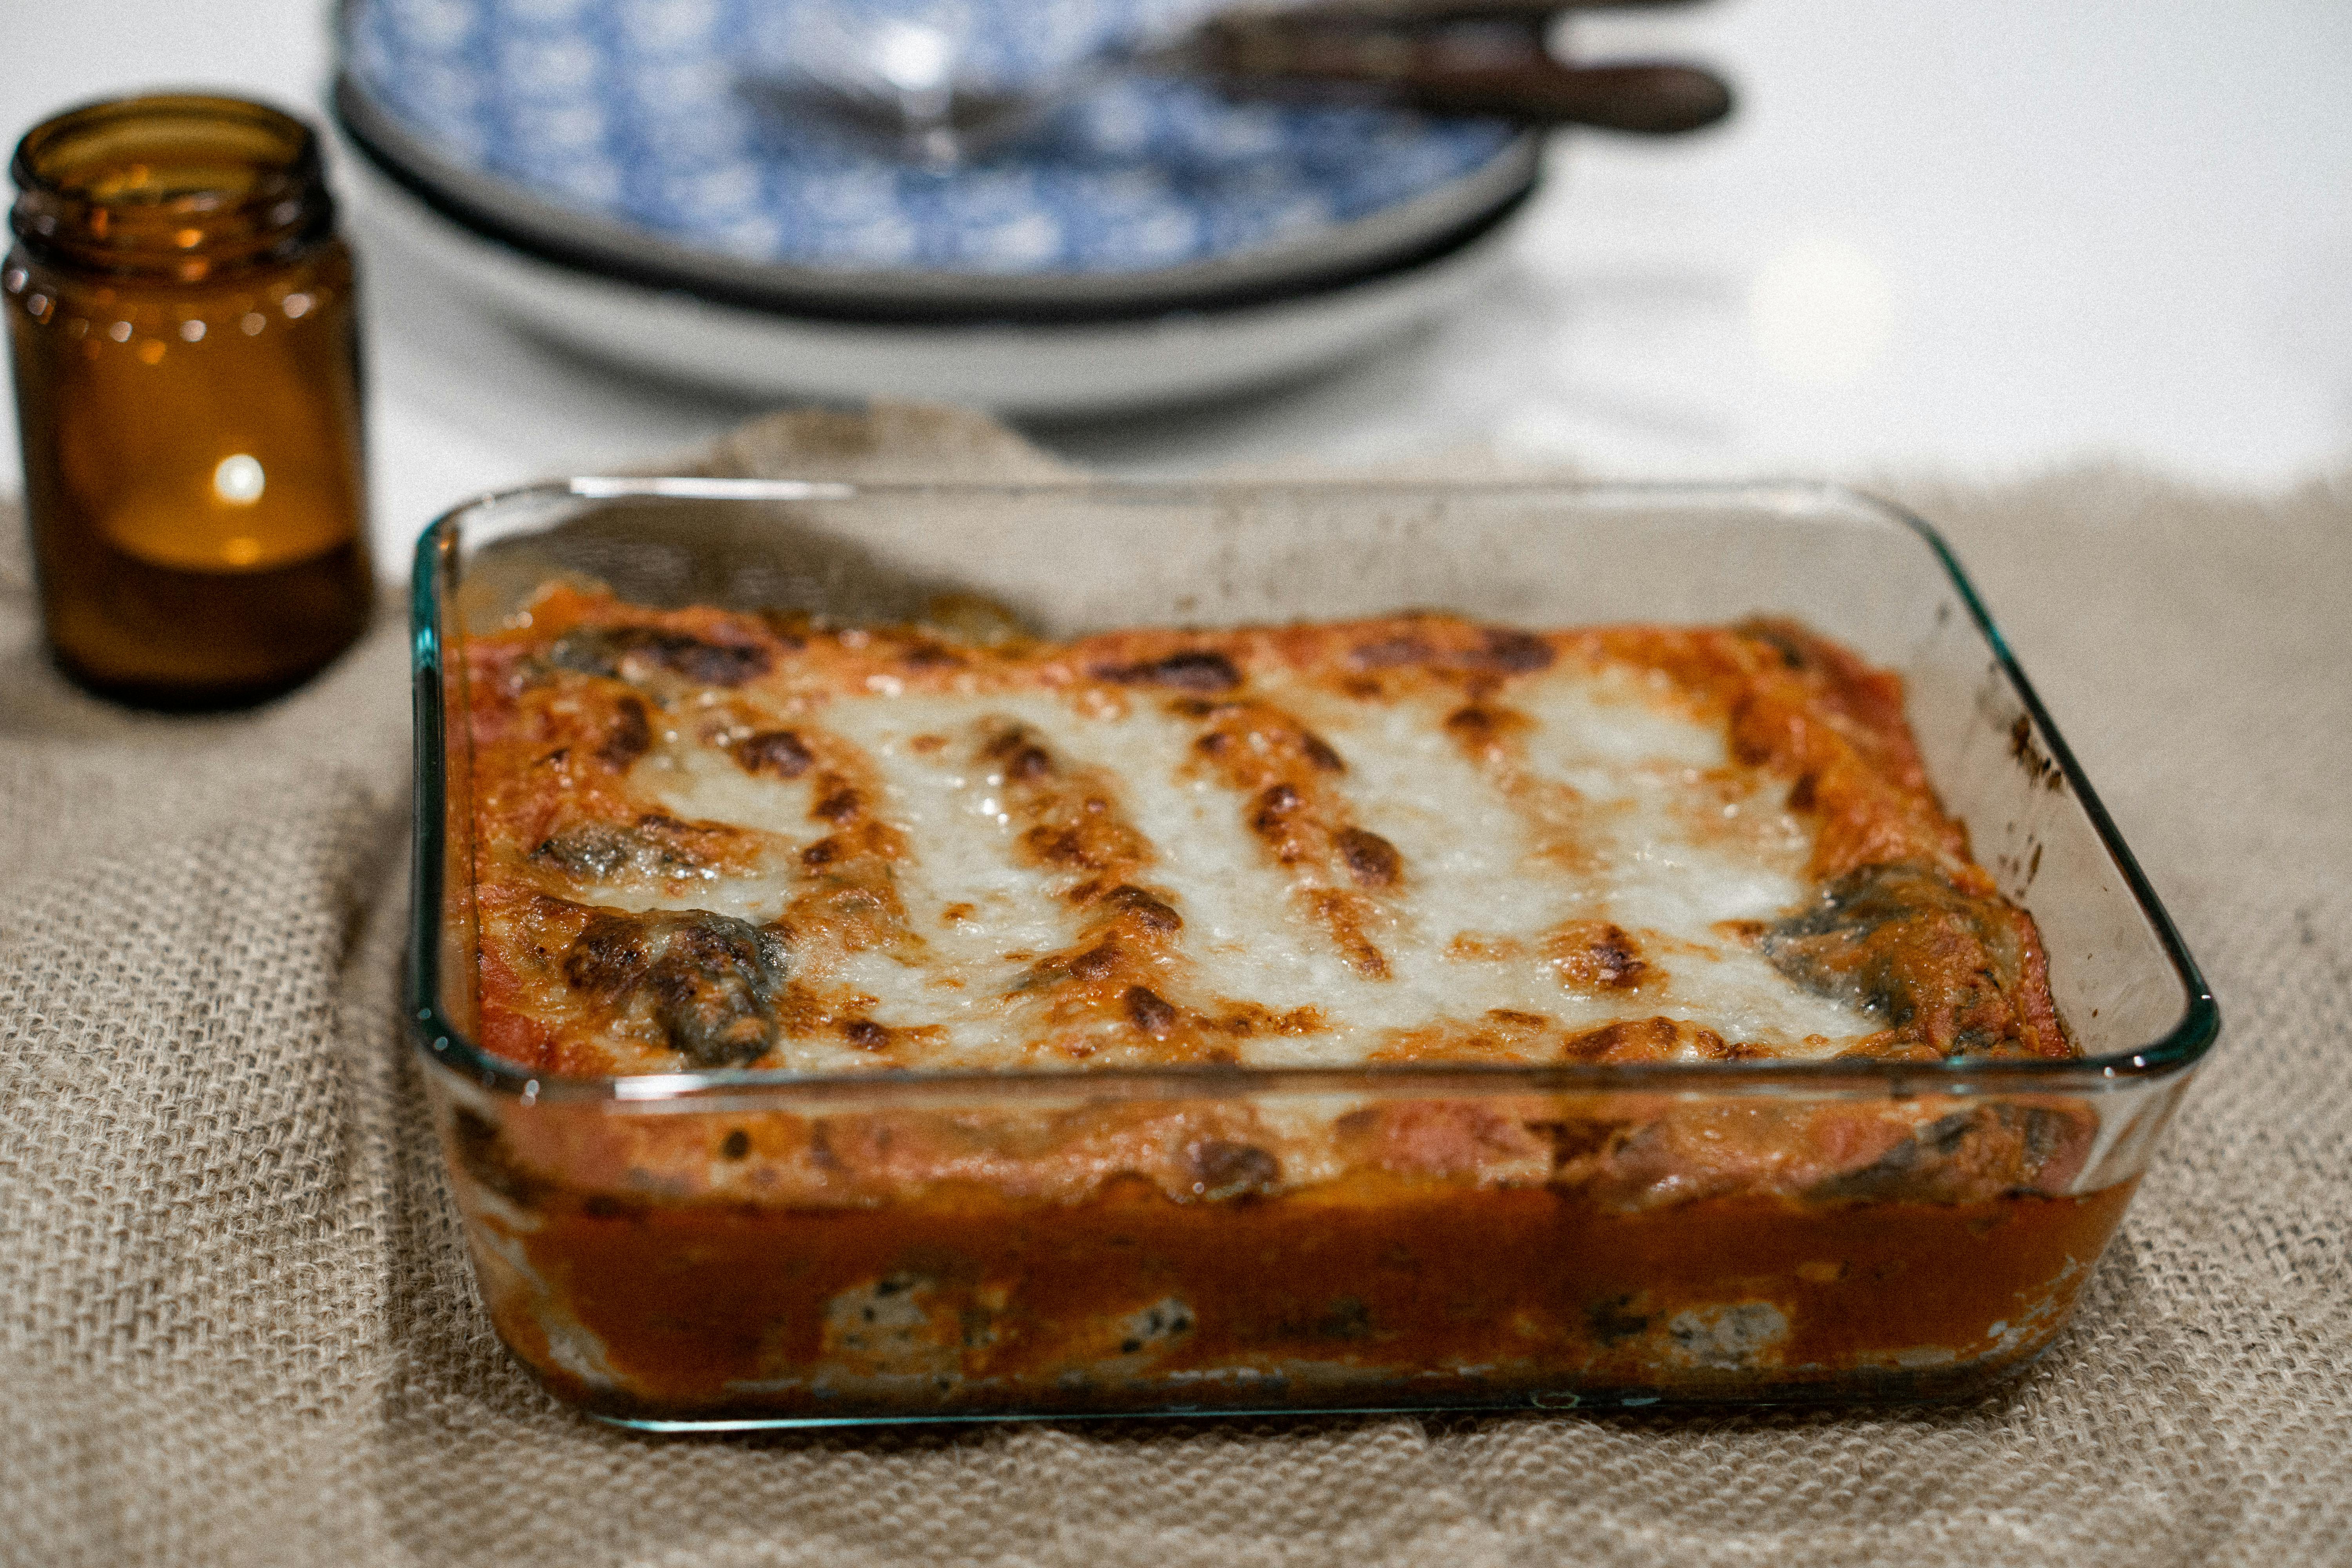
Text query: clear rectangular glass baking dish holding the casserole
412 479 2218 1429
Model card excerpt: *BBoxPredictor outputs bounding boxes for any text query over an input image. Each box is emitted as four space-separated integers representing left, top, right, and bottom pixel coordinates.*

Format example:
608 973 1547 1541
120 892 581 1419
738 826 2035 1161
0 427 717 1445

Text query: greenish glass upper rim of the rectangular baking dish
407 475 2220 1110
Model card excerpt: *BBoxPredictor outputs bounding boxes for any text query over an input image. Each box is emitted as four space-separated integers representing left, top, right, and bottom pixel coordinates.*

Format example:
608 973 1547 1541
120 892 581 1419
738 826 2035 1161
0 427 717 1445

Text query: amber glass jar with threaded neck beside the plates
0 96 374 708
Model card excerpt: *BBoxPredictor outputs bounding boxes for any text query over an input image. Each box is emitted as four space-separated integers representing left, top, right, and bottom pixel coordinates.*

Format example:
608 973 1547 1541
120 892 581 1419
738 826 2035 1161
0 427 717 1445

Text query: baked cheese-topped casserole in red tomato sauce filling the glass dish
447 585 2124 1415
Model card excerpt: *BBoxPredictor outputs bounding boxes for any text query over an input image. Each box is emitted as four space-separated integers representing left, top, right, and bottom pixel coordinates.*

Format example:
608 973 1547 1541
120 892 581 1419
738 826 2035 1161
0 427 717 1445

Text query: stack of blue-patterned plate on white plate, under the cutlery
334 0 1538 414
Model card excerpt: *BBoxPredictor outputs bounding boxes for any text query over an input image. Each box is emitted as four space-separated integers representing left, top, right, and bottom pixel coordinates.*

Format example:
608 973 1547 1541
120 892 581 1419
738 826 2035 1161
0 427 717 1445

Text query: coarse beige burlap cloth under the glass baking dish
0 414 2352 1568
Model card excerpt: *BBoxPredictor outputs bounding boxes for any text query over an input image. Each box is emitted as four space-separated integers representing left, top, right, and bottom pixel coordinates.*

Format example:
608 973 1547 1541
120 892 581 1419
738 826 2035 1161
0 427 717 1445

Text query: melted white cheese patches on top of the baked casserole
626 661 1884 1070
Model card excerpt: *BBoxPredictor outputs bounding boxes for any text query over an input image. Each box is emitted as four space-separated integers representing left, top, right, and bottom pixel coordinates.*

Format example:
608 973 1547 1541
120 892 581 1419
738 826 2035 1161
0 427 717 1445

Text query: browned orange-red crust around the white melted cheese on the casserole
466 588 2070 1091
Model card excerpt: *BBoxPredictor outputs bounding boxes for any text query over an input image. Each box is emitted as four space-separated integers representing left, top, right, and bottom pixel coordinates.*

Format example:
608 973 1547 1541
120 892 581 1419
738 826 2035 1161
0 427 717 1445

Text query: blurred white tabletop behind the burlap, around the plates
0 0 2352 569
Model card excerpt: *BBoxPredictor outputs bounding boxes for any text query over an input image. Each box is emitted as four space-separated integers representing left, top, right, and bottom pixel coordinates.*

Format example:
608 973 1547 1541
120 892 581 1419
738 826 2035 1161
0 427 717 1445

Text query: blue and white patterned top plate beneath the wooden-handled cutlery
339 0 1536 313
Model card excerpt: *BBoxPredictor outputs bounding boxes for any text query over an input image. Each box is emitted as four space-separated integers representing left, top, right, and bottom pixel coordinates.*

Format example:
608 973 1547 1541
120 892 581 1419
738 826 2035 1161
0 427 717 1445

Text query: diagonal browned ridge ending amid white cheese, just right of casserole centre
1169 698 1404 980
